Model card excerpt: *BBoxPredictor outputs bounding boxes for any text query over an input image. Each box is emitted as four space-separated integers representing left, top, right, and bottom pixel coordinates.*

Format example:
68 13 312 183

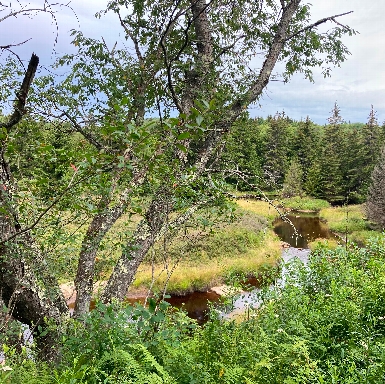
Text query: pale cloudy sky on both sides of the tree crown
0 0 385 124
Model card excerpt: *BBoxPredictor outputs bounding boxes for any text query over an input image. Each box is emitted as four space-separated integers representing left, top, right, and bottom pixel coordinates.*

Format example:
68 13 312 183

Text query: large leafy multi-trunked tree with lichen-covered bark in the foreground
0 0 354 360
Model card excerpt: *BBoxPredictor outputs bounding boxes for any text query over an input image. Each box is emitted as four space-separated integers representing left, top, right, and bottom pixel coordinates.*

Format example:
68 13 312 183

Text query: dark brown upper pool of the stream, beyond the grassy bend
274 213 335 248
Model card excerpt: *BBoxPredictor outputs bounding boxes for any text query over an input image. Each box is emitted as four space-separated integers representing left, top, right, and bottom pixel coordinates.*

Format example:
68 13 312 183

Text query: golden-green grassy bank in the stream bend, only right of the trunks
132 201 281 294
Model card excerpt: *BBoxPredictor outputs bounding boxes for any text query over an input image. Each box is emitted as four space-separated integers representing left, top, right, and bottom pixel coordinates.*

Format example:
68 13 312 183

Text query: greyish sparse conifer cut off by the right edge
365 147 385 229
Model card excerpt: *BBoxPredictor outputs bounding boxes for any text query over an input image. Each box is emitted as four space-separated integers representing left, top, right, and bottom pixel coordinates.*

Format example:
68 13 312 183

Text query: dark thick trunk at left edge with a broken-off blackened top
0 54 68 359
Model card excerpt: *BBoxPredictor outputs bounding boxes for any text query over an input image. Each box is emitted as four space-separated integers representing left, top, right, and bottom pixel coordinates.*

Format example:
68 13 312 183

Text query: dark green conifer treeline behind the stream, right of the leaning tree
222 104 385 203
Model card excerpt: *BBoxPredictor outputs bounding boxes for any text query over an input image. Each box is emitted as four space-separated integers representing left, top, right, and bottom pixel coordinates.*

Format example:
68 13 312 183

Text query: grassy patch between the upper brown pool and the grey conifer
320 204 376 244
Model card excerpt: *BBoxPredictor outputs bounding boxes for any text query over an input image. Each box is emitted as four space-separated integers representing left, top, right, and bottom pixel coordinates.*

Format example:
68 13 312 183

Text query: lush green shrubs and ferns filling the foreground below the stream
0 235 385 384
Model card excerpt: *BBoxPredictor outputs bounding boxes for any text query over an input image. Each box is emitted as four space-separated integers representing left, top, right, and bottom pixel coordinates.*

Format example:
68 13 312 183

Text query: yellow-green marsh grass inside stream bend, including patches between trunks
45 200 281 294
